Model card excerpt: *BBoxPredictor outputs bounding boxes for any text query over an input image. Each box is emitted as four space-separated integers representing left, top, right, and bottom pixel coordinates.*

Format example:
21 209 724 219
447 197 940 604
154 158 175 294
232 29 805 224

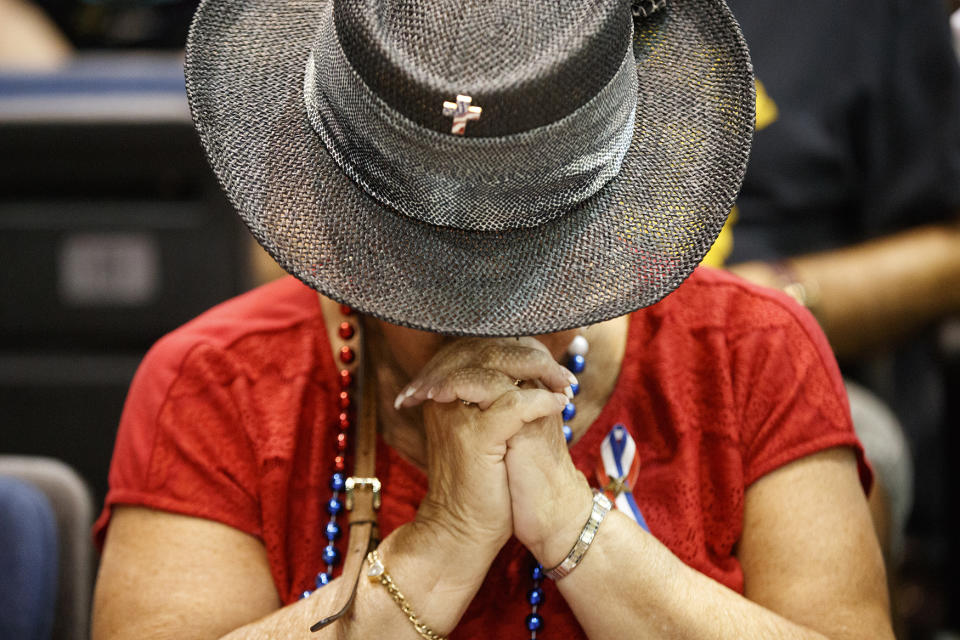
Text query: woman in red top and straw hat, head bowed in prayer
94 0 891 638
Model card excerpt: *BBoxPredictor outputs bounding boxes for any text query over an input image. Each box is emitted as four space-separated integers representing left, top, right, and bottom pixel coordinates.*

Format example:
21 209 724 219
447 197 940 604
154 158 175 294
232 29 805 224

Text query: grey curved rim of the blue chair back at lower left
0 455 94 640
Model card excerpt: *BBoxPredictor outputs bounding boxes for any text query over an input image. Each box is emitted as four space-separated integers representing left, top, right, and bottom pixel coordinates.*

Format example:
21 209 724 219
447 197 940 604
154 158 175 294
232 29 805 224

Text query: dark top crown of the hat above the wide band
334 0 632 137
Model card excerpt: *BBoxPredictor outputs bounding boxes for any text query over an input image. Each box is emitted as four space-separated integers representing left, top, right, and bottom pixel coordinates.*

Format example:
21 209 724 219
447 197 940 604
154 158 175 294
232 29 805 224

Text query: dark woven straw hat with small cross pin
186 0 754 335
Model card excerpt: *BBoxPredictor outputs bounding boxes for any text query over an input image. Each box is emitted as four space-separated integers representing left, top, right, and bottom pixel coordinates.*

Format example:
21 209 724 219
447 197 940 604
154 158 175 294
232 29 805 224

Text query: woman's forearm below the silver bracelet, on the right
557 512 883 640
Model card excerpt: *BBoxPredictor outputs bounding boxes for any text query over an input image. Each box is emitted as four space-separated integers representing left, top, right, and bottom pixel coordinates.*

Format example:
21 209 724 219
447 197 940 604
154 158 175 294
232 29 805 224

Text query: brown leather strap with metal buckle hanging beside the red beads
310 300 380 631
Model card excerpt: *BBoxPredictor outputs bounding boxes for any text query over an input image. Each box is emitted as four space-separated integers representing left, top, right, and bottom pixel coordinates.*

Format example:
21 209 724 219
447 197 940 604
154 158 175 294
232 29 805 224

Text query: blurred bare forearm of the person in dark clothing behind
731 225 960 358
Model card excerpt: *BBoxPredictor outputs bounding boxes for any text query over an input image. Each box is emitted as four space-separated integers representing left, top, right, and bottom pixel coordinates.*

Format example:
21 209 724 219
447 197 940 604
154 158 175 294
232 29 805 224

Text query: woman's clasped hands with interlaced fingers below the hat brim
397 338 591 567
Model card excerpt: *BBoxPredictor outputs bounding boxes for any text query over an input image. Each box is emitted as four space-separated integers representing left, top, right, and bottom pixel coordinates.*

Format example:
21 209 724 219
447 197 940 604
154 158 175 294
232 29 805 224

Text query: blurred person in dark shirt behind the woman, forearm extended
708 0 960 632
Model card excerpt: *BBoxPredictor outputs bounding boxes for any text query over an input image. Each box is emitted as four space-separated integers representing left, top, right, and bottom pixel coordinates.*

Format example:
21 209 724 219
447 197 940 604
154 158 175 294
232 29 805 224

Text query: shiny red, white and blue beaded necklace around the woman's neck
300 305 646 640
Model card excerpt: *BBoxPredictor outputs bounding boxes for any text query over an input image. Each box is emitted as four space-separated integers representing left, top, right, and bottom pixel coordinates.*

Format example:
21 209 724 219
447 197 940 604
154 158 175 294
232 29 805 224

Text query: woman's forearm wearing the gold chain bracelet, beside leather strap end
223 523 499 640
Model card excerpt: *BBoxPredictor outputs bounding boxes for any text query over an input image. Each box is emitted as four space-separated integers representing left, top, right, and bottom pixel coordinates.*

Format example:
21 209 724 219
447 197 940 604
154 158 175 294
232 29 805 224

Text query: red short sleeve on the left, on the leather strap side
94 333 260 547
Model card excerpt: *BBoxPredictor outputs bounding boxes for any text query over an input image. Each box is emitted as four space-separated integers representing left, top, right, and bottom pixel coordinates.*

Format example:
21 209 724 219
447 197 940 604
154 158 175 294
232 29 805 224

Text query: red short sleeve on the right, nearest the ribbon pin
731 287 872 491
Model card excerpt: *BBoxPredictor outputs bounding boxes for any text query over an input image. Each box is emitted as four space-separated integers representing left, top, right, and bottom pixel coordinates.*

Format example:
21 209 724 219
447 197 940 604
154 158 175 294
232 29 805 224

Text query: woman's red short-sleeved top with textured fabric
95 268 870 638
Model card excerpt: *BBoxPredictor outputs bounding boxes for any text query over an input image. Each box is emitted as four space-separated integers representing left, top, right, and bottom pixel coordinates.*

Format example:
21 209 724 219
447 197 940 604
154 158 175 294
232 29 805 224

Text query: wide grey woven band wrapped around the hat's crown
304 3 637 231
